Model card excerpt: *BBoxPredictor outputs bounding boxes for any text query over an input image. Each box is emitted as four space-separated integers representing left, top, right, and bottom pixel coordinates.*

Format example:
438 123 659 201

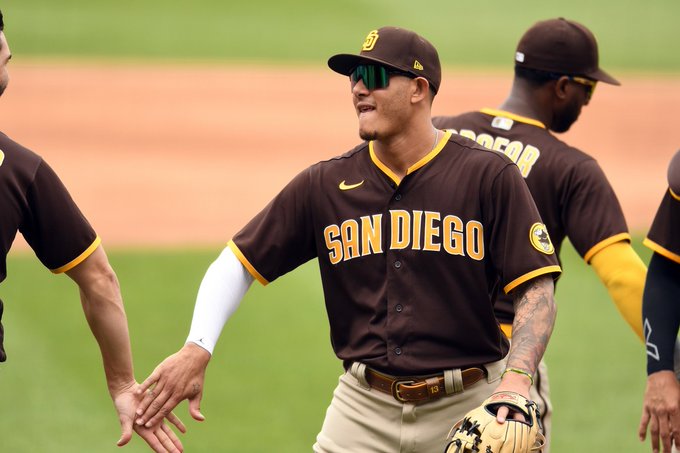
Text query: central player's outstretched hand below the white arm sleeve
135 343 210 428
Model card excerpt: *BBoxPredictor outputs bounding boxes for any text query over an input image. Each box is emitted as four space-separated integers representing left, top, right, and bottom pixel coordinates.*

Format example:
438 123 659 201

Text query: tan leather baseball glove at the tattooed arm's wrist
445 392 545 453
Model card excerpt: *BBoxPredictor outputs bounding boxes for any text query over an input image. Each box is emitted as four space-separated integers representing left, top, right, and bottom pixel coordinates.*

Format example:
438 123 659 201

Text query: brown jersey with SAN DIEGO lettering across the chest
229 129 560 375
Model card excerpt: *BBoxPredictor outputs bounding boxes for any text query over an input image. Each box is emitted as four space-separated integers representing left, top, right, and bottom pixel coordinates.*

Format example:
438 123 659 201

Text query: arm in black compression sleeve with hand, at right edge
638 253 680 451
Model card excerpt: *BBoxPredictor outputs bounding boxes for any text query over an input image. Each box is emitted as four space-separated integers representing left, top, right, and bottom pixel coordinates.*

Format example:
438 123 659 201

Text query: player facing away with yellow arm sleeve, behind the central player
433 18 645 452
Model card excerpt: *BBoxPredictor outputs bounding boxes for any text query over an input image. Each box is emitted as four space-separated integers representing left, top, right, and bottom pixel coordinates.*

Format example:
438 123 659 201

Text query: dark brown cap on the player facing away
515 17 621 85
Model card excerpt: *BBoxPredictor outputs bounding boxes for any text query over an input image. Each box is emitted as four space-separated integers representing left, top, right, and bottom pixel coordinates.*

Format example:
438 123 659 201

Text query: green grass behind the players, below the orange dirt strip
0 241 649 453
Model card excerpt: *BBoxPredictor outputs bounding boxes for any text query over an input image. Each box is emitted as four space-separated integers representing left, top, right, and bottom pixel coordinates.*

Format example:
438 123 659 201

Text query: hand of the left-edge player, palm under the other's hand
111 382 186 453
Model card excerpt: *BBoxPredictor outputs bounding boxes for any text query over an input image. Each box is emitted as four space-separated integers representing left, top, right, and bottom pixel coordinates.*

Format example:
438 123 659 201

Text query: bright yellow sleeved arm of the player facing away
590 241 647 342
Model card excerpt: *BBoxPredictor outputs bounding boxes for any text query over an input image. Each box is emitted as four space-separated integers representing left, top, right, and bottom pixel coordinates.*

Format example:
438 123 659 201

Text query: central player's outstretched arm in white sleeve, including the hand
136 247 254 427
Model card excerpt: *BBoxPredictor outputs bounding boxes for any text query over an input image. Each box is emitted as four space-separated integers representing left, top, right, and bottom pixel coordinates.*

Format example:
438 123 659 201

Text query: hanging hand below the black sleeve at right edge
638 371 680 453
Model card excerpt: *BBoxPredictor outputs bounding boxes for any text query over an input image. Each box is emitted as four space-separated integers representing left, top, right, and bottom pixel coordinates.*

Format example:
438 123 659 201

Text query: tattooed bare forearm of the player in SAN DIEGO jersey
497 275 557 423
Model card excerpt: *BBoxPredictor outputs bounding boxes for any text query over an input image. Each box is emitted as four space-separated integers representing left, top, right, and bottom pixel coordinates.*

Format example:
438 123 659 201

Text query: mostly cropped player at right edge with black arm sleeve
639 151 680 453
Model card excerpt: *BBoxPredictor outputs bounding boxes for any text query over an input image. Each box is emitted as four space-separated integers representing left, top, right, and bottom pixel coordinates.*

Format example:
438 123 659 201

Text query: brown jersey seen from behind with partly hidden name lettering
433 109 630 324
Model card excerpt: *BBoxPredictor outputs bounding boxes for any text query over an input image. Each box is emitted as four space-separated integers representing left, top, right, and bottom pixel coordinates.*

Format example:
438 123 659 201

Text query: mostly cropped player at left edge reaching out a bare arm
0 12 184 452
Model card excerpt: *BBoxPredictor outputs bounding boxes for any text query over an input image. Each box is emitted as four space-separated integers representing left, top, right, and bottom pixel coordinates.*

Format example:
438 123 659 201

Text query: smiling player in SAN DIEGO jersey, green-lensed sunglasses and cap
138 27 560 453
